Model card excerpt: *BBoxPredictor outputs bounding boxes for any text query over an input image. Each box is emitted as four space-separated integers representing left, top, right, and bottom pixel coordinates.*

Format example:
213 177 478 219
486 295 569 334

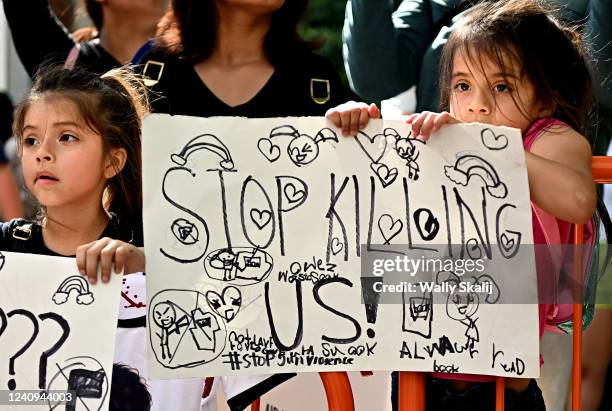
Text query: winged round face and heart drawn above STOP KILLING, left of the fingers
257 125 338 167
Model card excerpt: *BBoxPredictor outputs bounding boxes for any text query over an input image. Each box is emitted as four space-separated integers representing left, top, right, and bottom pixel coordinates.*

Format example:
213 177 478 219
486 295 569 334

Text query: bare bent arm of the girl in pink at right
525 127 597 224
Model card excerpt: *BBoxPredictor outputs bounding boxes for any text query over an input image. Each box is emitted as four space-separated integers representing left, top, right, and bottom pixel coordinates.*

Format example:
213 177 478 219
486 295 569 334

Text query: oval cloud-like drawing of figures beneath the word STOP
204 247 274 286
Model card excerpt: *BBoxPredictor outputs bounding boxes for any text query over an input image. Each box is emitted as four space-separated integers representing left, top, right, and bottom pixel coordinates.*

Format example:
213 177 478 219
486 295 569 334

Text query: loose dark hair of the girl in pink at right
440 0 591 134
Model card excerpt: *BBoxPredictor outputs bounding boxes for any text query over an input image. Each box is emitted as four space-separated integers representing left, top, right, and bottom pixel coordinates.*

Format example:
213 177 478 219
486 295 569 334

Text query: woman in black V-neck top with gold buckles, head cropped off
141 0 347 117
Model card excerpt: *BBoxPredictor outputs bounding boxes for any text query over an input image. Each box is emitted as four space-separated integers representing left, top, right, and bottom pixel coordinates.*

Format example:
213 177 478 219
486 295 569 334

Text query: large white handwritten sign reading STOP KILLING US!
143 115 539 378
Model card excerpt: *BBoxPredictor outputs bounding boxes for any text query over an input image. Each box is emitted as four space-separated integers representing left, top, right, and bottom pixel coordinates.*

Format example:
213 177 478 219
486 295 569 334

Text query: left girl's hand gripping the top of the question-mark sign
76 237 145 284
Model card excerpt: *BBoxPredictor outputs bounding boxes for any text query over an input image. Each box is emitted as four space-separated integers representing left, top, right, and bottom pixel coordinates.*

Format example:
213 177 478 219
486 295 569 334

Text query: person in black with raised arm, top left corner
3 0 168 77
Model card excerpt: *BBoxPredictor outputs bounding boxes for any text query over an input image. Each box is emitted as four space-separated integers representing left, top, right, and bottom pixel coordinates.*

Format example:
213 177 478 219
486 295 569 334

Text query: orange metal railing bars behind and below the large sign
251 157 612 411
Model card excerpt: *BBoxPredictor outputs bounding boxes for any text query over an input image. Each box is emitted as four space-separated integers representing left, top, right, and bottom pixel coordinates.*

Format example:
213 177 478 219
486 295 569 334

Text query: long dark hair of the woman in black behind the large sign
157 0 316 66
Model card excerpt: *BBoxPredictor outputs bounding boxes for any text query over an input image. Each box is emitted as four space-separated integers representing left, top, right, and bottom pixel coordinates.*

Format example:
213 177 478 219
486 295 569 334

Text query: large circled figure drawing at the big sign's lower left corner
149 290 227 369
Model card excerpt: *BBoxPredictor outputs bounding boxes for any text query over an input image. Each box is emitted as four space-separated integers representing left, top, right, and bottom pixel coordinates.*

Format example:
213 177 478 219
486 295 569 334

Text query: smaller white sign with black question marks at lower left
0 253 120 410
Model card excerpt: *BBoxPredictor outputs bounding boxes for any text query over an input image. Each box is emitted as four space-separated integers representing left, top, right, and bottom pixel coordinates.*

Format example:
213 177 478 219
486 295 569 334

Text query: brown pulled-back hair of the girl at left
13 66 148 241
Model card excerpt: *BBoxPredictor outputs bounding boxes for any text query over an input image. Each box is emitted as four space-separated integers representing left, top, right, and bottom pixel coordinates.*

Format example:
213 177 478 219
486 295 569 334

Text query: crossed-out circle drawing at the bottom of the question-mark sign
46 356 110 411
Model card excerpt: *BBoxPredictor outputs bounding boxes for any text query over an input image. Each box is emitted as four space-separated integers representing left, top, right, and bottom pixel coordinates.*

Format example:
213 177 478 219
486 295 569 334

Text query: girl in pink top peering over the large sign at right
327 0 597 410
